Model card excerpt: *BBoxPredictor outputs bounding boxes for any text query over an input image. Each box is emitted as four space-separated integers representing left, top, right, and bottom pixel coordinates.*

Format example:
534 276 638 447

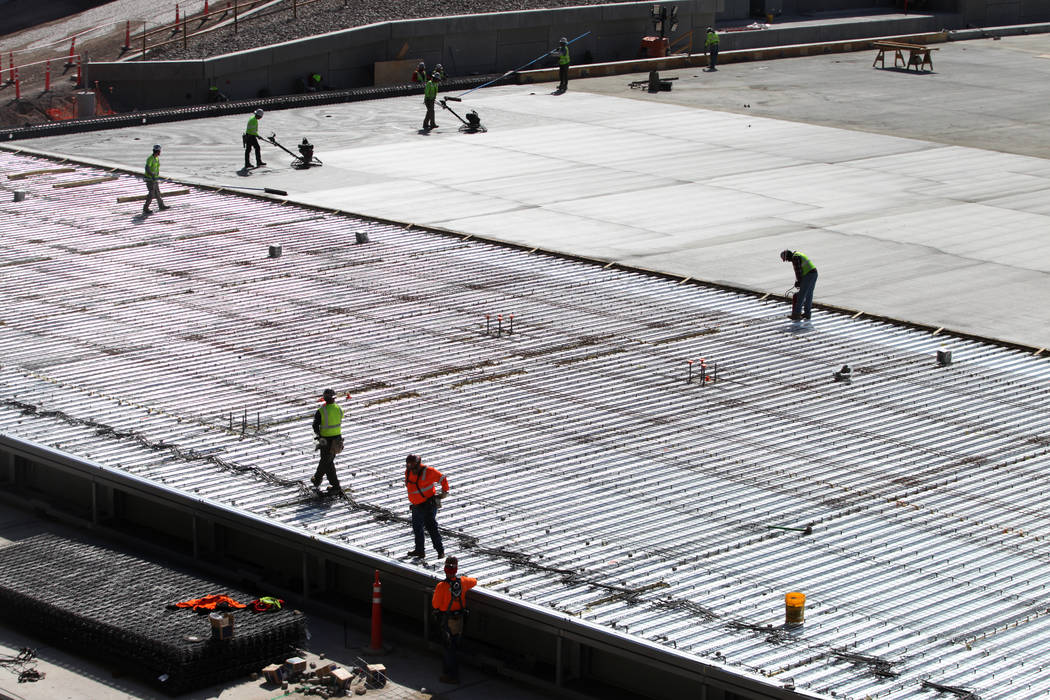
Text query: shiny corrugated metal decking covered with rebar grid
0 152 1050 700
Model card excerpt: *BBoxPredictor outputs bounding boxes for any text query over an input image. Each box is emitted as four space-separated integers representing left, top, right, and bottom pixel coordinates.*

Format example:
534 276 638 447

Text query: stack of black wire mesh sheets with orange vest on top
0 534 307 693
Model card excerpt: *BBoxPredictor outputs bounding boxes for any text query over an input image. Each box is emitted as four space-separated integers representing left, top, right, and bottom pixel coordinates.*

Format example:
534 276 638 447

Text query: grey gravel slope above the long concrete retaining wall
150 0 626 60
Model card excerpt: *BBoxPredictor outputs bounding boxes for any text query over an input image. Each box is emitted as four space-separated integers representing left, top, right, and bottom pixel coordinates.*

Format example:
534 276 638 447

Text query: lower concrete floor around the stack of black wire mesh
0 504 549 700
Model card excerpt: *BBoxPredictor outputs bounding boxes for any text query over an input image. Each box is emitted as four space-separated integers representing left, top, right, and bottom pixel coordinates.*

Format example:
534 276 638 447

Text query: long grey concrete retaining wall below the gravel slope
87 0 722 109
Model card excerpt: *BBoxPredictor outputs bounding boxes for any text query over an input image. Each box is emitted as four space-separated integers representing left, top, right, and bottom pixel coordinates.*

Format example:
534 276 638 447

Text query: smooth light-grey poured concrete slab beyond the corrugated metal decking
12 35 1050 347
